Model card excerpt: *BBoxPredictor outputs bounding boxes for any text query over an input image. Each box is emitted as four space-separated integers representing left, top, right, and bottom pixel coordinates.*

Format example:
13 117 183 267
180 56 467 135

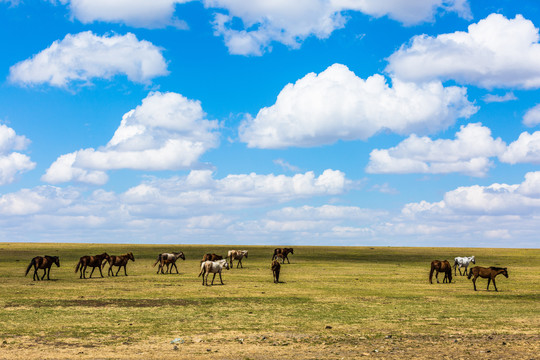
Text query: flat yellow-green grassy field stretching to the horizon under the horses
0 243 540 360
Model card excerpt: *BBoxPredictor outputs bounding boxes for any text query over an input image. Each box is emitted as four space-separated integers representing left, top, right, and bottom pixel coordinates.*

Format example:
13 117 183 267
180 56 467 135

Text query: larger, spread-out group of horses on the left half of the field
24 248 294 285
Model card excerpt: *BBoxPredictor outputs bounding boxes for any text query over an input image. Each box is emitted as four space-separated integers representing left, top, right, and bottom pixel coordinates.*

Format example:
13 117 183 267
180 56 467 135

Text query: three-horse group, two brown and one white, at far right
429 256 508 291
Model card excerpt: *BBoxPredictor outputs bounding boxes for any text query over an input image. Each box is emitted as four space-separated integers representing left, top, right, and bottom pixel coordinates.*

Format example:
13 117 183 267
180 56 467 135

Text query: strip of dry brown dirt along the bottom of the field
0 334 540 360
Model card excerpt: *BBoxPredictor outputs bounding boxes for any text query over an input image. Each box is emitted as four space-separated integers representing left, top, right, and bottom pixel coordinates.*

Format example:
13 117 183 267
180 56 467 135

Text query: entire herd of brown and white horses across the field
25 252 508 291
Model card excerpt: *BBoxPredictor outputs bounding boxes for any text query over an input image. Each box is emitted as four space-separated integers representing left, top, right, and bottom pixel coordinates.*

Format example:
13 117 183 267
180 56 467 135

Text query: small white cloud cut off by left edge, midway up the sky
0 124 36 185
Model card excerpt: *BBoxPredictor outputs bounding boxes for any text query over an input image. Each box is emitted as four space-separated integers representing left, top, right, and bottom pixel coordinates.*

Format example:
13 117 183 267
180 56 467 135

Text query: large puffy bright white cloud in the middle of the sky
239 64 477 148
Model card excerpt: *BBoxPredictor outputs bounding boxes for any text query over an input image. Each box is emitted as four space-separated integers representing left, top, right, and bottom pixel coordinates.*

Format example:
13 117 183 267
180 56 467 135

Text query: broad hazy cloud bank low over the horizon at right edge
384 172 540 248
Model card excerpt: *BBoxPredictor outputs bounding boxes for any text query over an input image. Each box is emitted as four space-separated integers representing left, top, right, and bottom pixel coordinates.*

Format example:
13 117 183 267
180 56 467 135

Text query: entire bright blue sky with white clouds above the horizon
0 0 540 248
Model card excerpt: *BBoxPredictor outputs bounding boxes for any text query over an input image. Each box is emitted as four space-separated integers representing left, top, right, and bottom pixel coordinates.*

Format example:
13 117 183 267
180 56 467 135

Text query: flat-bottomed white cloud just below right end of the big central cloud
366 123 506 176
